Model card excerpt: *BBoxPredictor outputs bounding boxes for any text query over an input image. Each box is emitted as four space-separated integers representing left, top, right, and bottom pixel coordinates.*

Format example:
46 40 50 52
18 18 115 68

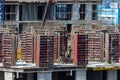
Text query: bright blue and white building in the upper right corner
98 0 120 27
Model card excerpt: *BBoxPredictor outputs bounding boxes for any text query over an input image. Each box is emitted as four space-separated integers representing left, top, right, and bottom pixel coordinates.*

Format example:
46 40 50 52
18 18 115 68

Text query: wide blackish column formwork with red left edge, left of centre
34 34 57 67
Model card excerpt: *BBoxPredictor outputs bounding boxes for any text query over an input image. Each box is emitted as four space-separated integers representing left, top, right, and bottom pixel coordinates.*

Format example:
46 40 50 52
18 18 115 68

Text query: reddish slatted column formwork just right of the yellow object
21 32 34 63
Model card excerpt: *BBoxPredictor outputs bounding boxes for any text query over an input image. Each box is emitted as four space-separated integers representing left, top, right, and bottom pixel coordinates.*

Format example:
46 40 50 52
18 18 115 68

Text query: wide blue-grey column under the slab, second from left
37 72 52 80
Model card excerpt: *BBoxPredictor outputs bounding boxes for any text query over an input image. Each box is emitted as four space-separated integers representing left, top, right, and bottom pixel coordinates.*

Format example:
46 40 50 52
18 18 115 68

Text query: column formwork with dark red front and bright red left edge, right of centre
71 34 88 66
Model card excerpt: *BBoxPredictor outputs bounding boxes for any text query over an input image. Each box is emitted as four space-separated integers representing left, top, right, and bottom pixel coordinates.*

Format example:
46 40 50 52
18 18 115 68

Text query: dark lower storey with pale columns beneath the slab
0 69 120 80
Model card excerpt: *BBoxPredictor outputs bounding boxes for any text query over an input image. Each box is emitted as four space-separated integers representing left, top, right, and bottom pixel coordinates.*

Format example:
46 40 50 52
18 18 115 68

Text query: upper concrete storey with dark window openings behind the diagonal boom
1 0 101 31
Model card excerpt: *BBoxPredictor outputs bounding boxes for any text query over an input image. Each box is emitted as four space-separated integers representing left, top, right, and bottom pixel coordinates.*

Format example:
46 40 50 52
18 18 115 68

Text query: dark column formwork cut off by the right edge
106 33 120 63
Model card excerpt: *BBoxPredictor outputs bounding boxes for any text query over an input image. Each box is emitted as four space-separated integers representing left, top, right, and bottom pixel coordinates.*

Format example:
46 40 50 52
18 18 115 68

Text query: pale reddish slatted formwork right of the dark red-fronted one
88 32 104 62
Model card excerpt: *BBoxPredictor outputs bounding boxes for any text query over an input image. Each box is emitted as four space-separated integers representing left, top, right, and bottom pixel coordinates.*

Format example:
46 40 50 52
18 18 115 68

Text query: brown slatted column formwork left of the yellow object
2 33 17 67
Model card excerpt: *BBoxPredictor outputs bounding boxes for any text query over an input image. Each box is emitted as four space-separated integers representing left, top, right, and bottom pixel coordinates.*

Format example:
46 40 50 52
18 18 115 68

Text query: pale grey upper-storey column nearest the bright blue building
85 4 92 20
